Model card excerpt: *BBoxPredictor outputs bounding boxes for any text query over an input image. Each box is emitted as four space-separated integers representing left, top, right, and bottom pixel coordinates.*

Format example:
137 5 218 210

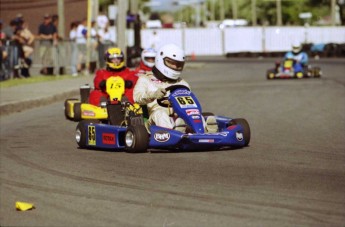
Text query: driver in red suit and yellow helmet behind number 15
89 47 138 106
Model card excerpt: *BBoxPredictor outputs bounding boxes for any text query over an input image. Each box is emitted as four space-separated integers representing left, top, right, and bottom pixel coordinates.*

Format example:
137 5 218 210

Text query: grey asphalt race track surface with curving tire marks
0 59 345 226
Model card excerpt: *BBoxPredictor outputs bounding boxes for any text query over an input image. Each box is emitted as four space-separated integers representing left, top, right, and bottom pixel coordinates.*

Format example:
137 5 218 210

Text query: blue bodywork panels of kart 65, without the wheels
80 88 245 150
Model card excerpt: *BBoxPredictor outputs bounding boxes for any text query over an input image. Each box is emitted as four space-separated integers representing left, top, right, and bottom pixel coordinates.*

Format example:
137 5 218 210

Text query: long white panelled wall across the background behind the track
141 26 345 55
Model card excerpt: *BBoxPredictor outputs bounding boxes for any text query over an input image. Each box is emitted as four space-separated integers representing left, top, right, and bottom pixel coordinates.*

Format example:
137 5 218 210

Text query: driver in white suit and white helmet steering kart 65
133 44 190 129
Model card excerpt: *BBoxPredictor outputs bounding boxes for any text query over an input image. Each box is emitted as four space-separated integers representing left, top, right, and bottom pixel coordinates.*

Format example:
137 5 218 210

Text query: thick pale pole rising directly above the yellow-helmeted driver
116 0 128 56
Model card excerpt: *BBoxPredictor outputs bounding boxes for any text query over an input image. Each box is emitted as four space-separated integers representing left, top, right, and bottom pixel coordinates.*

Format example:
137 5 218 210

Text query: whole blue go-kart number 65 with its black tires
76 85 250 152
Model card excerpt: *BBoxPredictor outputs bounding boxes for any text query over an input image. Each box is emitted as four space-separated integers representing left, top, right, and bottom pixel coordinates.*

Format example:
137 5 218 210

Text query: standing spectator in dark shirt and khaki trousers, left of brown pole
38 14 57 75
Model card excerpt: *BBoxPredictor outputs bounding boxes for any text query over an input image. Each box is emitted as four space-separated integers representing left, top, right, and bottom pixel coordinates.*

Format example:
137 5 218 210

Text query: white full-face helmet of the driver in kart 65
155 44 185 80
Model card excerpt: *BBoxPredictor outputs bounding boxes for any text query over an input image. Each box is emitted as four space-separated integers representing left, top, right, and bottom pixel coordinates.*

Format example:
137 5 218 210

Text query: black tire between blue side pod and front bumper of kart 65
125 125 149 153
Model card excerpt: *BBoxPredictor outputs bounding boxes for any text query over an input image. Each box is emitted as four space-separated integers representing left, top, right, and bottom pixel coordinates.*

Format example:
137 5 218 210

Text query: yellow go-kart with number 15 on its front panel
64 76 142 125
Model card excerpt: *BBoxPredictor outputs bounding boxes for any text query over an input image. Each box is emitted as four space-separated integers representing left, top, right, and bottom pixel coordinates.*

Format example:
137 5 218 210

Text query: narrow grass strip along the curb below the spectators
0 75 73 88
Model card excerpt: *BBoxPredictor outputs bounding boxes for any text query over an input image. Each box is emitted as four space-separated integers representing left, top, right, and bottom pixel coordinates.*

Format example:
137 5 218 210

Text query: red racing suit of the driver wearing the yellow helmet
89 67 138 106
